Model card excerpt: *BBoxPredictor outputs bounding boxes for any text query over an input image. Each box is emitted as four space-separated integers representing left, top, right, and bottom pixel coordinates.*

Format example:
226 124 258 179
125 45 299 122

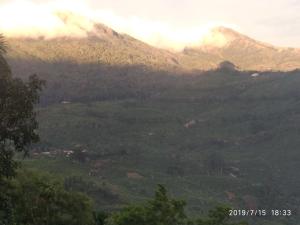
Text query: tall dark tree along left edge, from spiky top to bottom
0 35 44 225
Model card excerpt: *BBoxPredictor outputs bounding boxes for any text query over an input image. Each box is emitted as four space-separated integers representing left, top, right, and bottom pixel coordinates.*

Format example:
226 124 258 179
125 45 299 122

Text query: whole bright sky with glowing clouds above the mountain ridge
0 0 300 48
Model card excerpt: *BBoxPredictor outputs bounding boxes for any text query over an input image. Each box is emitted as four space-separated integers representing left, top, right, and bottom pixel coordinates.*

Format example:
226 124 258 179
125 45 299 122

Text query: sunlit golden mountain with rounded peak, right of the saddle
183 27 300 71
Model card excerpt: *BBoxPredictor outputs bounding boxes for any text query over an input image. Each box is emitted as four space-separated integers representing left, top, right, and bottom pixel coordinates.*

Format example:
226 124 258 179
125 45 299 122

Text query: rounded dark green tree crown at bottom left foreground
12 170 93 225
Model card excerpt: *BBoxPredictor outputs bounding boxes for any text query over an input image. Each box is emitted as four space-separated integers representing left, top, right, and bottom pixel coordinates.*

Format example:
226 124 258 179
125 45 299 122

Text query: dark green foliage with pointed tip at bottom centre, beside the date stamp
108 185 247 225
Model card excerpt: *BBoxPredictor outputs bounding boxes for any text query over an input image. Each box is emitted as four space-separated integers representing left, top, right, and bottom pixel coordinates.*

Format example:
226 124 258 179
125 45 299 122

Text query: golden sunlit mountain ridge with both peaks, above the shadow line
7 12 300 75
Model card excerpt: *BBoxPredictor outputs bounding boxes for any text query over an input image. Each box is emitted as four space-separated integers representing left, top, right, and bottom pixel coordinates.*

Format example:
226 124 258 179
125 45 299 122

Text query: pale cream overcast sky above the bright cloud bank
0 0 300 47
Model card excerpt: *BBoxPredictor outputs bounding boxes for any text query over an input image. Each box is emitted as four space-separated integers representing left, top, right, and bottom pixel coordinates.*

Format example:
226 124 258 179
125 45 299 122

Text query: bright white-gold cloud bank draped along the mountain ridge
0 0 236 50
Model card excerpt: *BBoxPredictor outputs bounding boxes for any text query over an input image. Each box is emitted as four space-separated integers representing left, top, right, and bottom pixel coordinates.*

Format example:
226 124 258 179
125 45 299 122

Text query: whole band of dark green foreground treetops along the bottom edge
0 170 247 225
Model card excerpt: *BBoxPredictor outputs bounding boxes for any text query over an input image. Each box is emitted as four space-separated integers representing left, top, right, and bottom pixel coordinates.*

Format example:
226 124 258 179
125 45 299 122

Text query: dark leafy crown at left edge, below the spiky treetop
0 57 43 179
